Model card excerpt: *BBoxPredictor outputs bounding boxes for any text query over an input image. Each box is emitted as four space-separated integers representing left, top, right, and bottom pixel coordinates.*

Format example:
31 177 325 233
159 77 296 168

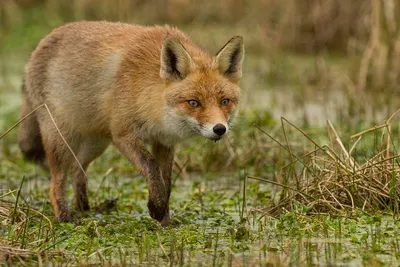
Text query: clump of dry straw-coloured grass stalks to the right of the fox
249 110 400 215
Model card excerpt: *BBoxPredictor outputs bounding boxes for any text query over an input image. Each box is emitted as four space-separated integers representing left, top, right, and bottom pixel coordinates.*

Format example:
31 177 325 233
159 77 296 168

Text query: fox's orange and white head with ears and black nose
160 36 244 141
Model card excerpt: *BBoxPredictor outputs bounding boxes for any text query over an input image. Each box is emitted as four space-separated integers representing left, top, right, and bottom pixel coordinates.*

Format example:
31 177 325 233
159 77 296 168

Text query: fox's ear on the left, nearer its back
160 36 192 81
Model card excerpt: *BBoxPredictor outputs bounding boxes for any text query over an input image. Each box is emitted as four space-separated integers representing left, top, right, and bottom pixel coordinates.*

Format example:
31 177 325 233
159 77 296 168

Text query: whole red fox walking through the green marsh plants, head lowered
18 22 244 226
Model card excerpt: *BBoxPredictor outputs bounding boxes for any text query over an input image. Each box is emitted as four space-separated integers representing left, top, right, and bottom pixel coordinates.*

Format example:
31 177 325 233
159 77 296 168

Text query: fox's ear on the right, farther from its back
216 36 244 82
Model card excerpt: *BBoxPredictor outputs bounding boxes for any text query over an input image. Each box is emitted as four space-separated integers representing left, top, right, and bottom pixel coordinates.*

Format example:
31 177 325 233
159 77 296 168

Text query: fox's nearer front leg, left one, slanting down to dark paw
113 135 168 222
